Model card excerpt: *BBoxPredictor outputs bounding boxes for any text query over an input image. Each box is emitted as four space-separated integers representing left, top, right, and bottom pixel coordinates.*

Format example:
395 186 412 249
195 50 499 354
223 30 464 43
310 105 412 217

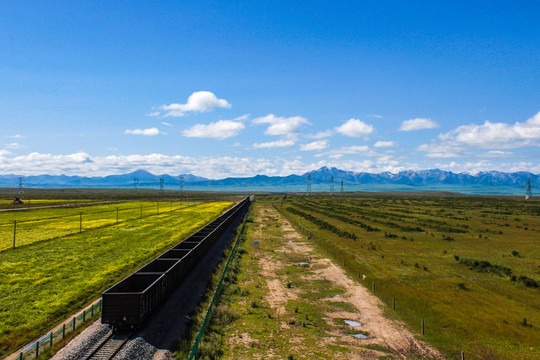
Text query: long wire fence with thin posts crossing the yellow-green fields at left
0 202 197 251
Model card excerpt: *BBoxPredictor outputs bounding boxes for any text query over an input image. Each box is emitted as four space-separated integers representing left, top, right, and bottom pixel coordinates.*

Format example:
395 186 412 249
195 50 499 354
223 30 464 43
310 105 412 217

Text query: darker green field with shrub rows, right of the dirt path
274 196 540 360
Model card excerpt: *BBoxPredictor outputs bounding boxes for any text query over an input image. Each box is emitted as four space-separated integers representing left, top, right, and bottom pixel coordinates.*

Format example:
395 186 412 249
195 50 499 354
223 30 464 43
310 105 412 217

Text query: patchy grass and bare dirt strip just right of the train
186 201 436 359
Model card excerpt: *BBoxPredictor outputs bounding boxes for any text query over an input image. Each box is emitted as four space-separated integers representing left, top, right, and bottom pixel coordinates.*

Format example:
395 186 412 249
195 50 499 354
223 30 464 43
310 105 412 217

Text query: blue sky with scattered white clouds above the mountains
0 1 540 178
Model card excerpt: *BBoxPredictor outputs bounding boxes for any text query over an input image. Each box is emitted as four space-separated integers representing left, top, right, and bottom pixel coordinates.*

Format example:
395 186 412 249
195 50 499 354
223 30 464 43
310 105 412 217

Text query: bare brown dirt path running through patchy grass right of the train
224 206 443 359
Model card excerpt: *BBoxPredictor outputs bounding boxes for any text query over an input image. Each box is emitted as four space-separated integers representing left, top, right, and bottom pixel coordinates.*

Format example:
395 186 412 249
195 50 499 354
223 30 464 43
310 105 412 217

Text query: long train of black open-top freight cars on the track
101 197 251 328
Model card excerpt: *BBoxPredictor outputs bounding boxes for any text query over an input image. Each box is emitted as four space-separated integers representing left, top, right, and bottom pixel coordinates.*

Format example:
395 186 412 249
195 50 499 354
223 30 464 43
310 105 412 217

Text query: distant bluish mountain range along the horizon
0 167 540 190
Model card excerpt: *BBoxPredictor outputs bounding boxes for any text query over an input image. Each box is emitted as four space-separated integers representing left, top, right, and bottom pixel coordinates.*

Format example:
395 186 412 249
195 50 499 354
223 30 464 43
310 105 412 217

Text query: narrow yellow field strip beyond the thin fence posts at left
0 200 197 251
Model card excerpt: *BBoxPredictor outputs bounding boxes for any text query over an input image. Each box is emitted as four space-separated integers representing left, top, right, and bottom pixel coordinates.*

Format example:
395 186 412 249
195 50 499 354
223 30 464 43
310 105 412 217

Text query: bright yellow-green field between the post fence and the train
0 202 231 355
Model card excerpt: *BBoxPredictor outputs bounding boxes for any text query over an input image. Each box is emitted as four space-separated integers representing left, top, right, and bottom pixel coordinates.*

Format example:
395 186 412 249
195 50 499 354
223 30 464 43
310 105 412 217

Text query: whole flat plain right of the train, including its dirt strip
193 193 540 360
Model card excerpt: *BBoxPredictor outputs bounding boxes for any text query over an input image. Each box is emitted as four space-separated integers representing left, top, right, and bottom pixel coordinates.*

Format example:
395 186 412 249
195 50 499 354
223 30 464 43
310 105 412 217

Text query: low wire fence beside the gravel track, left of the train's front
15 300 102 360
